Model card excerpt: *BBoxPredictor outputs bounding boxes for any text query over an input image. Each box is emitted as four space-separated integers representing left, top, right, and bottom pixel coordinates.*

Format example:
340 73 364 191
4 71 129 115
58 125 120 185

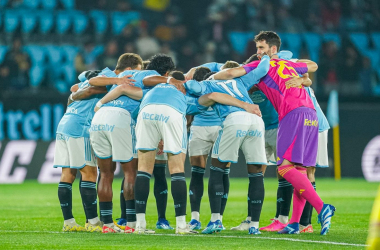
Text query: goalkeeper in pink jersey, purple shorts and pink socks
214 31 335 235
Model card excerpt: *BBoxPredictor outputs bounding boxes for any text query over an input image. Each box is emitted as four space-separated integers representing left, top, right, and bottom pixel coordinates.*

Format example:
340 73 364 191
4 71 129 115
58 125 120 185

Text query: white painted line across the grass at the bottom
0 230 367 247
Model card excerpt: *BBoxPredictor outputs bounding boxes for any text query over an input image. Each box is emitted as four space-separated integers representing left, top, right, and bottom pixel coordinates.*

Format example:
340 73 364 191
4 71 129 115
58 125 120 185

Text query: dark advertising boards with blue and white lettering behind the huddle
0 95 380 183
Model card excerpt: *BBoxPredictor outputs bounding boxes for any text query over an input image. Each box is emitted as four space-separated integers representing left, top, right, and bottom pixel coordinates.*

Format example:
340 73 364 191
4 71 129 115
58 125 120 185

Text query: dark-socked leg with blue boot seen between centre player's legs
153 156 173 229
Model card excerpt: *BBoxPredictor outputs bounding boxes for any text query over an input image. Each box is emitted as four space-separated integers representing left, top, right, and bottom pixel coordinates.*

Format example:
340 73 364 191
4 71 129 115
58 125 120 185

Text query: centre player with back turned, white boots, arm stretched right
135 72 260 234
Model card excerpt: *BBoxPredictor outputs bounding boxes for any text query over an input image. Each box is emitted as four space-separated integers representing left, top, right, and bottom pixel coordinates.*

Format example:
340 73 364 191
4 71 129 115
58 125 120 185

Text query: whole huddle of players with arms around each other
54 31 335 235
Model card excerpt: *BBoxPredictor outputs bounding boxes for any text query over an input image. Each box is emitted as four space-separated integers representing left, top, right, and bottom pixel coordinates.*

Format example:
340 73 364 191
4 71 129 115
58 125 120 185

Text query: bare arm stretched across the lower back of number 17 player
198 92 261 117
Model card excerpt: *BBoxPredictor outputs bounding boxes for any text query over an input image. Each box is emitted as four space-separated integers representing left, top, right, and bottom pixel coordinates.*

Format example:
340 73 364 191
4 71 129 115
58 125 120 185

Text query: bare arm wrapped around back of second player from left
95 84 144 112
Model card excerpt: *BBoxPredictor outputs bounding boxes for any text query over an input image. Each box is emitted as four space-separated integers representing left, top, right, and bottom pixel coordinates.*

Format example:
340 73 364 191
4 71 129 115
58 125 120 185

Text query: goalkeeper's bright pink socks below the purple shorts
278 165 323 215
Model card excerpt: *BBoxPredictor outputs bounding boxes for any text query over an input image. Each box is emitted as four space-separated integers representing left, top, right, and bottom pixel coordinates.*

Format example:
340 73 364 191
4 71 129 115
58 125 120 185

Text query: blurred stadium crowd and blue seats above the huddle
0 0 380 96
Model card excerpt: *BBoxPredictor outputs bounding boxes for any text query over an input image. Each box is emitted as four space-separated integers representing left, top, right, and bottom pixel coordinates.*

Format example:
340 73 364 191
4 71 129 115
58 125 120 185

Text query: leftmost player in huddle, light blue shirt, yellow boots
54 68 113 232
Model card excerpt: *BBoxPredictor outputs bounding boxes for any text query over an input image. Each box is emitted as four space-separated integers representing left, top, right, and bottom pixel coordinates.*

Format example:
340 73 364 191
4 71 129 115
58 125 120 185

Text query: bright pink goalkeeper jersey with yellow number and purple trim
243 59 315 121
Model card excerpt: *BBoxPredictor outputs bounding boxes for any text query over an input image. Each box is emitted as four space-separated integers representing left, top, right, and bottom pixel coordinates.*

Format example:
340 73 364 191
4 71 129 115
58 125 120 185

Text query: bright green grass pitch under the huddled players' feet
0 179 378 249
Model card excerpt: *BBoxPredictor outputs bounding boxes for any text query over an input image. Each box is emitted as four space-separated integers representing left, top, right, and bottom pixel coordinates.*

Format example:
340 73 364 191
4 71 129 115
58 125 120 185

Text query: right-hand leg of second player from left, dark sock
120 158 137 232
